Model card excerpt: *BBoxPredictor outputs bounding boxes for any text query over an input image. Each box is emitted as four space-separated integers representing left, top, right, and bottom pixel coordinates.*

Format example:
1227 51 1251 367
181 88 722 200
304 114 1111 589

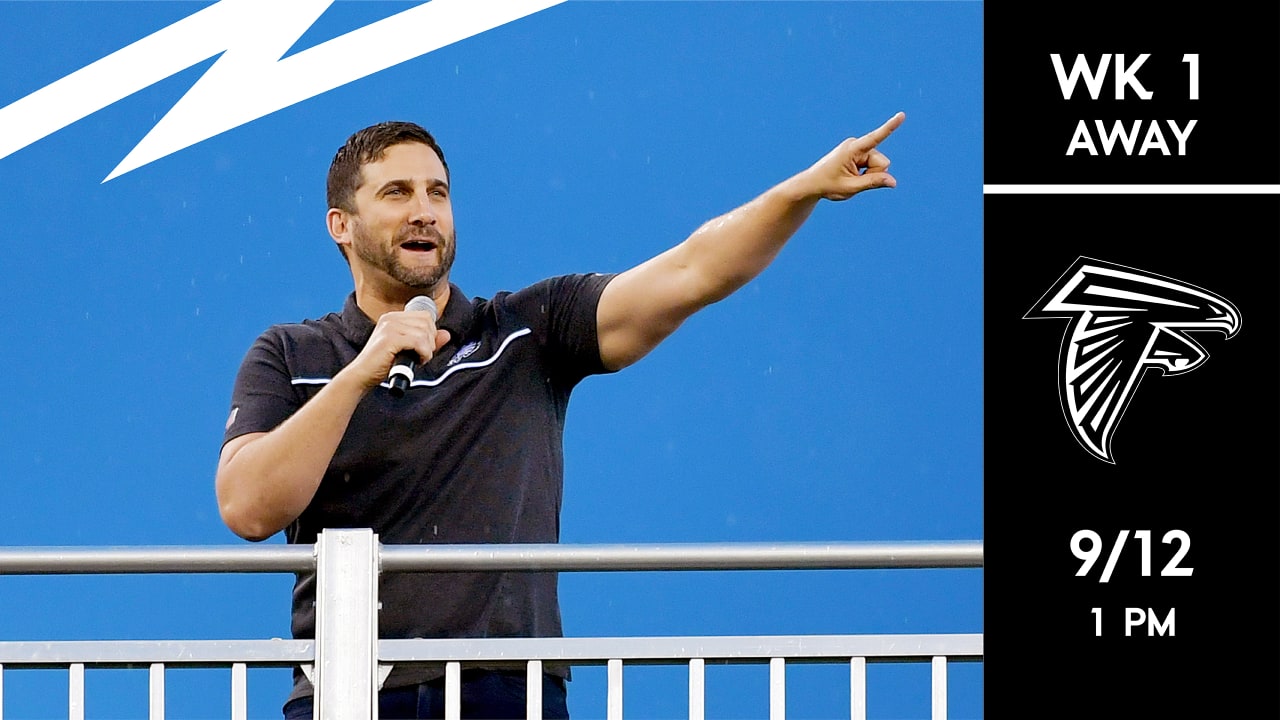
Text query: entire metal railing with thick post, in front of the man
0 529 983 720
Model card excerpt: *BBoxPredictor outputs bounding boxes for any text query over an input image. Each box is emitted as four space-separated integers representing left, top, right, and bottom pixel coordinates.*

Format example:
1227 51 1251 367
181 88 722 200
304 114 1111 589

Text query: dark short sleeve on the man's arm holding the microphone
223 332 302 445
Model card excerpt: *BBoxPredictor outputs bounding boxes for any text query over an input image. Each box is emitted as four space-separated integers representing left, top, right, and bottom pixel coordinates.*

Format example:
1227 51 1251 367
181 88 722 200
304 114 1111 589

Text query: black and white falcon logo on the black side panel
1023 258 1240 464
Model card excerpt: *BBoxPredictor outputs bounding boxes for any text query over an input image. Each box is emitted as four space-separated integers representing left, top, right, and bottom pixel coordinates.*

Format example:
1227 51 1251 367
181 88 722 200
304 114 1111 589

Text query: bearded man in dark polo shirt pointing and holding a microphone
216 113 904 719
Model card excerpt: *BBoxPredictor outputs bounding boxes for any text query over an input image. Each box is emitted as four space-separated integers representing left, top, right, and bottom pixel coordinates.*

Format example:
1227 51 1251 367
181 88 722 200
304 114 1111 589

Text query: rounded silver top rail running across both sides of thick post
0 541 983 575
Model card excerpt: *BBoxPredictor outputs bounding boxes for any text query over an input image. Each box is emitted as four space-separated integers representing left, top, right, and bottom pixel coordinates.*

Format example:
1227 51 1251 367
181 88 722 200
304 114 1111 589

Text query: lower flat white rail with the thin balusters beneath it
0 634 983 720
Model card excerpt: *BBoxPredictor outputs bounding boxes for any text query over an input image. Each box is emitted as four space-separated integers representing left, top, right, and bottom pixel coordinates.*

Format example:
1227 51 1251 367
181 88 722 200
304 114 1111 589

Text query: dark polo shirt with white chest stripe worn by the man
224 274 613 696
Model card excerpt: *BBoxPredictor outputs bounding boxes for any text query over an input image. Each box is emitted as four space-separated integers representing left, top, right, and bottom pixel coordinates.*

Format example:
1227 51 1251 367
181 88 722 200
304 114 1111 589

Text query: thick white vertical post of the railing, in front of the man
314 528 379 720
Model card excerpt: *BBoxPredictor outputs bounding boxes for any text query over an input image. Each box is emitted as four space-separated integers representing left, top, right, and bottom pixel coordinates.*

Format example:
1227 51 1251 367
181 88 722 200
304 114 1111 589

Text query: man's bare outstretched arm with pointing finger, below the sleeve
596 113 905 370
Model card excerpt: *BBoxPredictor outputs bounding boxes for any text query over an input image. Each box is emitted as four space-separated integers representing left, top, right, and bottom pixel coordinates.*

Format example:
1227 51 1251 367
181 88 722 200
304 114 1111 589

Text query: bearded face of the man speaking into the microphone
349 142 457 291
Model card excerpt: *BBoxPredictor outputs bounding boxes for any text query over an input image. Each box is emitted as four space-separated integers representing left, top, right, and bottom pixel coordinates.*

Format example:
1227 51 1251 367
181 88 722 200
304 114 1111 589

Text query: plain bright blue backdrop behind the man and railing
0 0 983 719
